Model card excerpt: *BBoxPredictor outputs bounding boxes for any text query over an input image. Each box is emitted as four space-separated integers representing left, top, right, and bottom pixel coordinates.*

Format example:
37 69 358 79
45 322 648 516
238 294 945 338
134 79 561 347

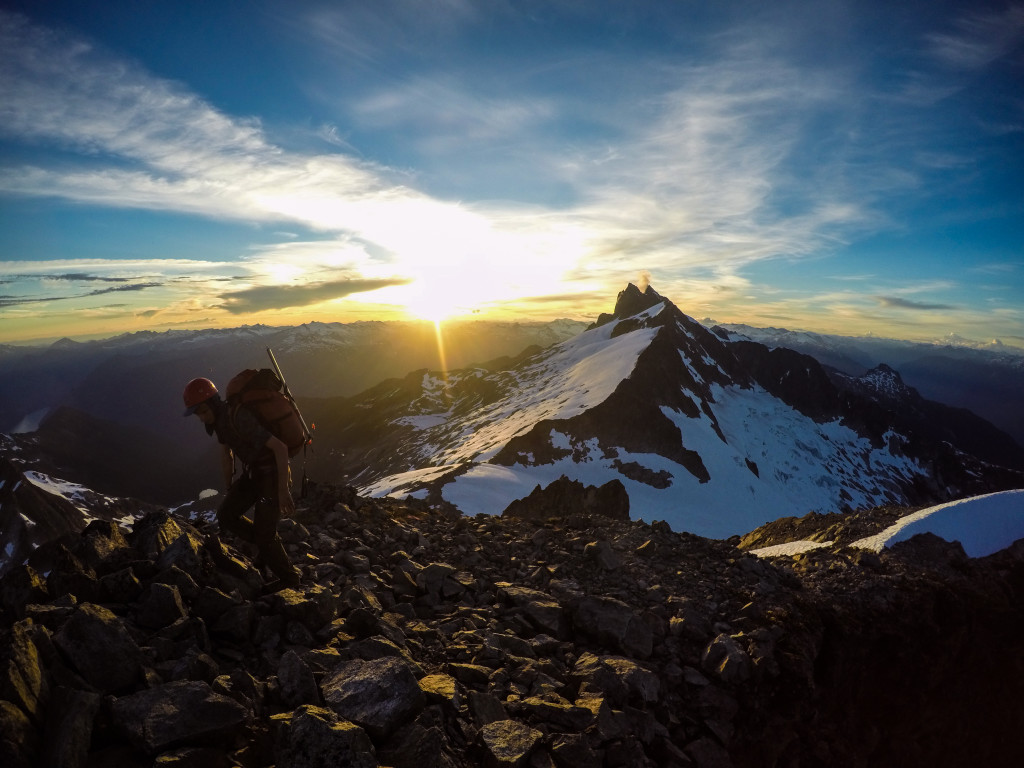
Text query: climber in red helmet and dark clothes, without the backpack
183 379 301 592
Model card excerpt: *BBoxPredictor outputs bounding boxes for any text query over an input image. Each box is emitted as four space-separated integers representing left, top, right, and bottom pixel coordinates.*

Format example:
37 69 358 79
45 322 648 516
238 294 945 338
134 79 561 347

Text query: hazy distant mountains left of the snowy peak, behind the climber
0 321 586 504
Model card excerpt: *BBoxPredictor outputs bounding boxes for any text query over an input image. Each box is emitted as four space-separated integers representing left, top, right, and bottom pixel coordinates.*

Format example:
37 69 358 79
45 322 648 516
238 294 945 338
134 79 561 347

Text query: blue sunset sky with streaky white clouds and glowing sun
0 0 1024 350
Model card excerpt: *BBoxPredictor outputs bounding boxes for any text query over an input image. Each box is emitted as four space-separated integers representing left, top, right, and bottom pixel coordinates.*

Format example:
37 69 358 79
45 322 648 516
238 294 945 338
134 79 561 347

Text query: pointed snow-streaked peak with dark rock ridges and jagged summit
331 286 1024 538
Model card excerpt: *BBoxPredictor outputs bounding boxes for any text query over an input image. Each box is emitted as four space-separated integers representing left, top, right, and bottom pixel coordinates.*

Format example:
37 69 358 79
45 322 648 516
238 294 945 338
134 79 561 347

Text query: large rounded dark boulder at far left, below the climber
53 603 142 692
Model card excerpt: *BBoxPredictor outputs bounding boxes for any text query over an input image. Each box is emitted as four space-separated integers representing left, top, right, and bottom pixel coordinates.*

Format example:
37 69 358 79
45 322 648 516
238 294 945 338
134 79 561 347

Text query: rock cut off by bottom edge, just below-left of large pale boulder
271 705 378 768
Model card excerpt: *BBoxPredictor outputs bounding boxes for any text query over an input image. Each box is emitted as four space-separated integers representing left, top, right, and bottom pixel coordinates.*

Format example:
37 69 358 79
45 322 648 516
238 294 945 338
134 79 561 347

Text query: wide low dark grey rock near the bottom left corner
111 681 248 756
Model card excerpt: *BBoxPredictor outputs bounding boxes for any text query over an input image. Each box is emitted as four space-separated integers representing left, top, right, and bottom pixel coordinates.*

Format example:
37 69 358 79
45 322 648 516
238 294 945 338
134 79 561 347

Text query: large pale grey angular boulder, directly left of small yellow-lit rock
323 656 426 738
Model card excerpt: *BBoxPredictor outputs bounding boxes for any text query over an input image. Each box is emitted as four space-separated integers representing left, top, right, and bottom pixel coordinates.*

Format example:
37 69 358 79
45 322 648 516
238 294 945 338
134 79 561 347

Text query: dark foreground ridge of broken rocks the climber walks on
0 480 1024 768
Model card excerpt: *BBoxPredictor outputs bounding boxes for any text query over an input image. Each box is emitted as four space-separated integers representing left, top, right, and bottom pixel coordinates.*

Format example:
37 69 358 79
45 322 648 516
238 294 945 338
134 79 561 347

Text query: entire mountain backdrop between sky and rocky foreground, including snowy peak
0 286 1024 536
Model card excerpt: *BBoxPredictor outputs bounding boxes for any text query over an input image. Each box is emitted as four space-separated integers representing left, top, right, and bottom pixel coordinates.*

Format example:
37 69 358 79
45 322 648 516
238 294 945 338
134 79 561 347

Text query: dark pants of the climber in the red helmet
217 467 299 581
